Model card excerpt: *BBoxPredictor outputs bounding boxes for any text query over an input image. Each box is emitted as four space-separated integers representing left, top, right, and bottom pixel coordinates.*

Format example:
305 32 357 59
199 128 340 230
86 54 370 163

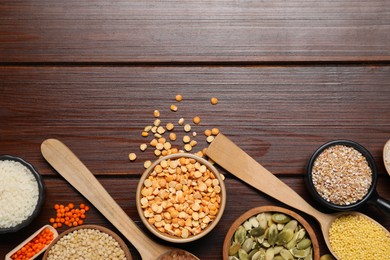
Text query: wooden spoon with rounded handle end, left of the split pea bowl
41 139 199 260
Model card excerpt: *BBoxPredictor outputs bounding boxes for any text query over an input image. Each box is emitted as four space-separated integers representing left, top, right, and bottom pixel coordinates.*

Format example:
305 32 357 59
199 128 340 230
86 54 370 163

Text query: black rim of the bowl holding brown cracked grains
304 139 378 211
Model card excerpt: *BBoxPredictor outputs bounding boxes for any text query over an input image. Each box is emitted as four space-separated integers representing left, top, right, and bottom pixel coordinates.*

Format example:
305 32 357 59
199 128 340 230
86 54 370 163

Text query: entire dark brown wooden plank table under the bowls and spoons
0 0 390 259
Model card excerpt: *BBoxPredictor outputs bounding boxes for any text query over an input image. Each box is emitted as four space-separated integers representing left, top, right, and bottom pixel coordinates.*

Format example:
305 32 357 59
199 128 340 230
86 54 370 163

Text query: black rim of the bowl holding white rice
0 155 45 235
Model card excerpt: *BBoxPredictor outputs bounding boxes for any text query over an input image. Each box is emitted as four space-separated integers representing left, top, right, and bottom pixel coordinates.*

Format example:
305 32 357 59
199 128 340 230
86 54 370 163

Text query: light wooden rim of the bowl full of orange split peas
136 153 227 243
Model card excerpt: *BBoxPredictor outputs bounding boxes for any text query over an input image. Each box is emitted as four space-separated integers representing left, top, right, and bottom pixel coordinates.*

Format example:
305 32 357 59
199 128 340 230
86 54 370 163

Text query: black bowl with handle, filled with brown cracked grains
305 140 390 214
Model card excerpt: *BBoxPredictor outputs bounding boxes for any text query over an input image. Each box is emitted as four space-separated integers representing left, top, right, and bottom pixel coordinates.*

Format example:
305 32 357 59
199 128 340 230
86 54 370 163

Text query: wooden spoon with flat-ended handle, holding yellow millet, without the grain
207 134 389 257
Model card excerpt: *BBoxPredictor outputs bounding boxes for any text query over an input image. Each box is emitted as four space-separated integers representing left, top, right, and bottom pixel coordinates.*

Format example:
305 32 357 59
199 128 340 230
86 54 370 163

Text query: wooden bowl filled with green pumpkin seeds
222 206 320 260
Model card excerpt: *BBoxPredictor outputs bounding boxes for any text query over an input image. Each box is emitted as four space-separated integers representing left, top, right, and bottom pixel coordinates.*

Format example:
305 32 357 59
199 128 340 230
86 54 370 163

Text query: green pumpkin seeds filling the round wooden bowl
229 212 313 260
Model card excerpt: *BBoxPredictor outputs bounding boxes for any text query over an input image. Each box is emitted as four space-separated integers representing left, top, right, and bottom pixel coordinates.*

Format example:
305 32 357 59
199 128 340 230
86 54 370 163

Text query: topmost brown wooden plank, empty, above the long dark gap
0 0 390 63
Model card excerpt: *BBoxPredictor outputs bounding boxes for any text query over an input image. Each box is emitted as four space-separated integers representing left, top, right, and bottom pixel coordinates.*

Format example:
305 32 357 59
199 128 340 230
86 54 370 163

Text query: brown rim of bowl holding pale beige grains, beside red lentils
42 225 133 260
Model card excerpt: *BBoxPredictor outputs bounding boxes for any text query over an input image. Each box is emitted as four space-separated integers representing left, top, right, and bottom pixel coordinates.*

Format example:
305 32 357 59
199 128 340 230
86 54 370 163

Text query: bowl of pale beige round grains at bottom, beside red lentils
42 225 132 260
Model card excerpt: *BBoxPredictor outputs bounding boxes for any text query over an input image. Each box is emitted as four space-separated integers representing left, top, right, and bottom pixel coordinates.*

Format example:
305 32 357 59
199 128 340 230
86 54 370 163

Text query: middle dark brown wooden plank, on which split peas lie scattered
0 66 390 175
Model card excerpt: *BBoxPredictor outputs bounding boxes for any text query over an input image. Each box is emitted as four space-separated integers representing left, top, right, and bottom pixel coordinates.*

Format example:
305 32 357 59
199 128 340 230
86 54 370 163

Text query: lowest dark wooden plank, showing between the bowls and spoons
0 176 390 260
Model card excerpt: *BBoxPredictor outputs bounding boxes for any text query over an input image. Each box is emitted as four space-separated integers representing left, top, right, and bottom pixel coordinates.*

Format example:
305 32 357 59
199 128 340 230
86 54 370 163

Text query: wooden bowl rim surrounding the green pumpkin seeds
222 206 320 260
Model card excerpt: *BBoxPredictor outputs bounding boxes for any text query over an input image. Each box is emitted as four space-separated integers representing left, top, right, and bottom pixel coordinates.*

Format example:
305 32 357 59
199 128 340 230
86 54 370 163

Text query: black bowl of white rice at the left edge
0 155 45 234
